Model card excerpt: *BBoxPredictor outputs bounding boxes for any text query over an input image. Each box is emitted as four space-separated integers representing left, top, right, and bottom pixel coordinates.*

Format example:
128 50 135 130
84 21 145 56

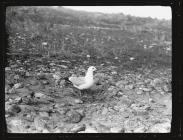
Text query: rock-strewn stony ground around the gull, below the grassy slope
5 54 172 133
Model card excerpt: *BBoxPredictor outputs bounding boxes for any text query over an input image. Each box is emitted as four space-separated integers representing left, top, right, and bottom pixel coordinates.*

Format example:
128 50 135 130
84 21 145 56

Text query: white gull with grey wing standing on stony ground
69 66 97 90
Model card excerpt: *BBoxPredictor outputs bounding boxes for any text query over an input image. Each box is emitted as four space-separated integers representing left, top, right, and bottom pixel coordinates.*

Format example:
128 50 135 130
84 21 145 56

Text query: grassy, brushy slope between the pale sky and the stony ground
6 6 171 68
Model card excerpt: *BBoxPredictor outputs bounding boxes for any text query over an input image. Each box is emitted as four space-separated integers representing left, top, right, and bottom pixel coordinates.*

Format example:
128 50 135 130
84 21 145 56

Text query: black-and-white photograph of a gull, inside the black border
5 6 172 134
